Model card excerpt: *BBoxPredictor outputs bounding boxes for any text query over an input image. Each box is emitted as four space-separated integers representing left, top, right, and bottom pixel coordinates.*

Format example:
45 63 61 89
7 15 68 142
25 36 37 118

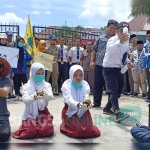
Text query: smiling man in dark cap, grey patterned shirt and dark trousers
90 20 118 109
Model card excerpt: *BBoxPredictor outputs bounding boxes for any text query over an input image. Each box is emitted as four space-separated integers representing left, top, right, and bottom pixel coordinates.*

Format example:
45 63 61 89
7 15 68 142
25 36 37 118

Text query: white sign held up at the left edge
0 46 19 68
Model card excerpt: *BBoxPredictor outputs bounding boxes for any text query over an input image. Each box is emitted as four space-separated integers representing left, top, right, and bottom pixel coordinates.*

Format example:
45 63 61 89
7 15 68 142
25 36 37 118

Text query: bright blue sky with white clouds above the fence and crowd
0 0 132 36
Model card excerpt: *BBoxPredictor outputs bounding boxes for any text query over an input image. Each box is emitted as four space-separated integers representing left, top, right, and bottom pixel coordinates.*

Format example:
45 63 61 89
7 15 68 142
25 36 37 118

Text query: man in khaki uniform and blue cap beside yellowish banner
46 35 59 96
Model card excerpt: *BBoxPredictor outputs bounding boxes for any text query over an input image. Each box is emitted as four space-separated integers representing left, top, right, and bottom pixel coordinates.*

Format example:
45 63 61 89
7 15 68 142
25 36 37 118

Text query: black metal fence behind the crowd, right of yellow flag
33 26 103 43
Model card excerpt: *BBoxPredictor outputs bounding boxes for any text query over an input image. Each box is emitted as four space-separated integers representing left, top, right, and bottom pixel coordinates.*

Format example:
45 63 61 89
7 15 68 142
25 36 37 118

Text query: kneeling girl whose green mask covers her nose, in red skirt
13 63 54 139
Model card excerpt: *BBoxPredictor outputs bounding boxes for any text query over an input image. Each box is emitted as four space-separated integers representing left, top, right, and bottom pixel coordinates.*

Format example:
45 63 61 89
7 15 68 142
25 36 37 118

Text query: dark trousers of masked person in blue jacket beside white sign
14 73 27 95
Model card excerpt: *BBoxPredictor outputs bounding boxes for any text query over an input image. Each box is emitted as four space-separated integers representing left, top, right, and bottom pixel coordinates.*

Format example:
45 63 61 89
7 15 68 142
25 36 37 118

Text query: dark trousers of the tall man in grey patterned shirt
93 65 105 106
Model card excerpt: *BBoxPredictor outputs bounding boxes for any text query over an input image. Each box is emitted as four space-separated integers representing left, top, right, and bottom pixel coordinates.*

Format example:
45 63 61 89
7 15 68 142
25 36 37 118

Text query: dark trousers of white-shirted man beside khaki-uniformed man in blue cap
58 63 67 89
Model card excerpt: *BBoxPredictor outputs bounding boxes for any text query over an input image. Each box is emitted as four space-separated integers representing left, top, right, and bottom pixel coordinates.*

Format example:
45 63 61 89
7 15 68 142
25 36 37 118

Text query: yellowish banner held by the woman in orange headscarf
32 52 54 70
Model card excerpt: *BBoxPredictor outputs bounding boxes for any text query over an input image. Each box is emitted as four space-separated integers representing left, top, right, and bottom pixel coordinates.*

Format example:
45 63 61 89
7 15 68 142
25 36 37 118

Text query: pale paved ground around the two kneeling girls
8 95 148 143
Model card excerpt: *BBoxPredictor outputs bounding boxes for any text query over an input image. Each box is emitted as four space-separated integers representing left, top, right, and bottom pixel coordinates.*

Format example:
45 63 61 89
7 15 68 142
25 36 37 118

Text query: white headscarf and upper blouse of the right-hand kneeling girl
62 65 90 117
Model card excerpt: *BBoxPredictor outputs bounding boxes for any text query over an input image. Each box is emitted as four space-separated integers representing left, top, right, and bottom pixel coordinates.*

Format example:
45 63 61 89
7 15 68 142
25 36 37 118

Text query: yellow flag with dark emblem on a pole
24 16 37 55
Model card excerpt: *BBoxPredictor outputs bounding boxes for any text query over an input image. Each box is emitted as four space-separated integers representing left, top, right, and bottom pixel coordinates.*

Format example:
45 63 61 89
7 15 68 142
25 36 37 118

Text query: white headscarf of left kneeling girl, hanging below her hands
23 63 48 119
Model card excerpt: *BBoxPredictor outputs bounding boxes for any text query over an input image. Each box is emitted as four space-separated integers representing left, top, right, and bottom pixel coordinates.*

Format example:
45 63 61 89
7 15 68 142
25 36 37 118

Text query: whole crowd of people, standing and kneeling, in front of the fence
0 20 150 141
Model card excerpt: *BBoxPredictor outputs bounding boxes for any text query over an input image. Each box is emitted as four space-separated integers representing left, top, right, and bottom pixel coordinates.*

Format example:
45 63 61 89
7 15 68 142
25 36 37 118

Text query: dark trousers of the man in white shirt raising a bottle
103 68 124 110
